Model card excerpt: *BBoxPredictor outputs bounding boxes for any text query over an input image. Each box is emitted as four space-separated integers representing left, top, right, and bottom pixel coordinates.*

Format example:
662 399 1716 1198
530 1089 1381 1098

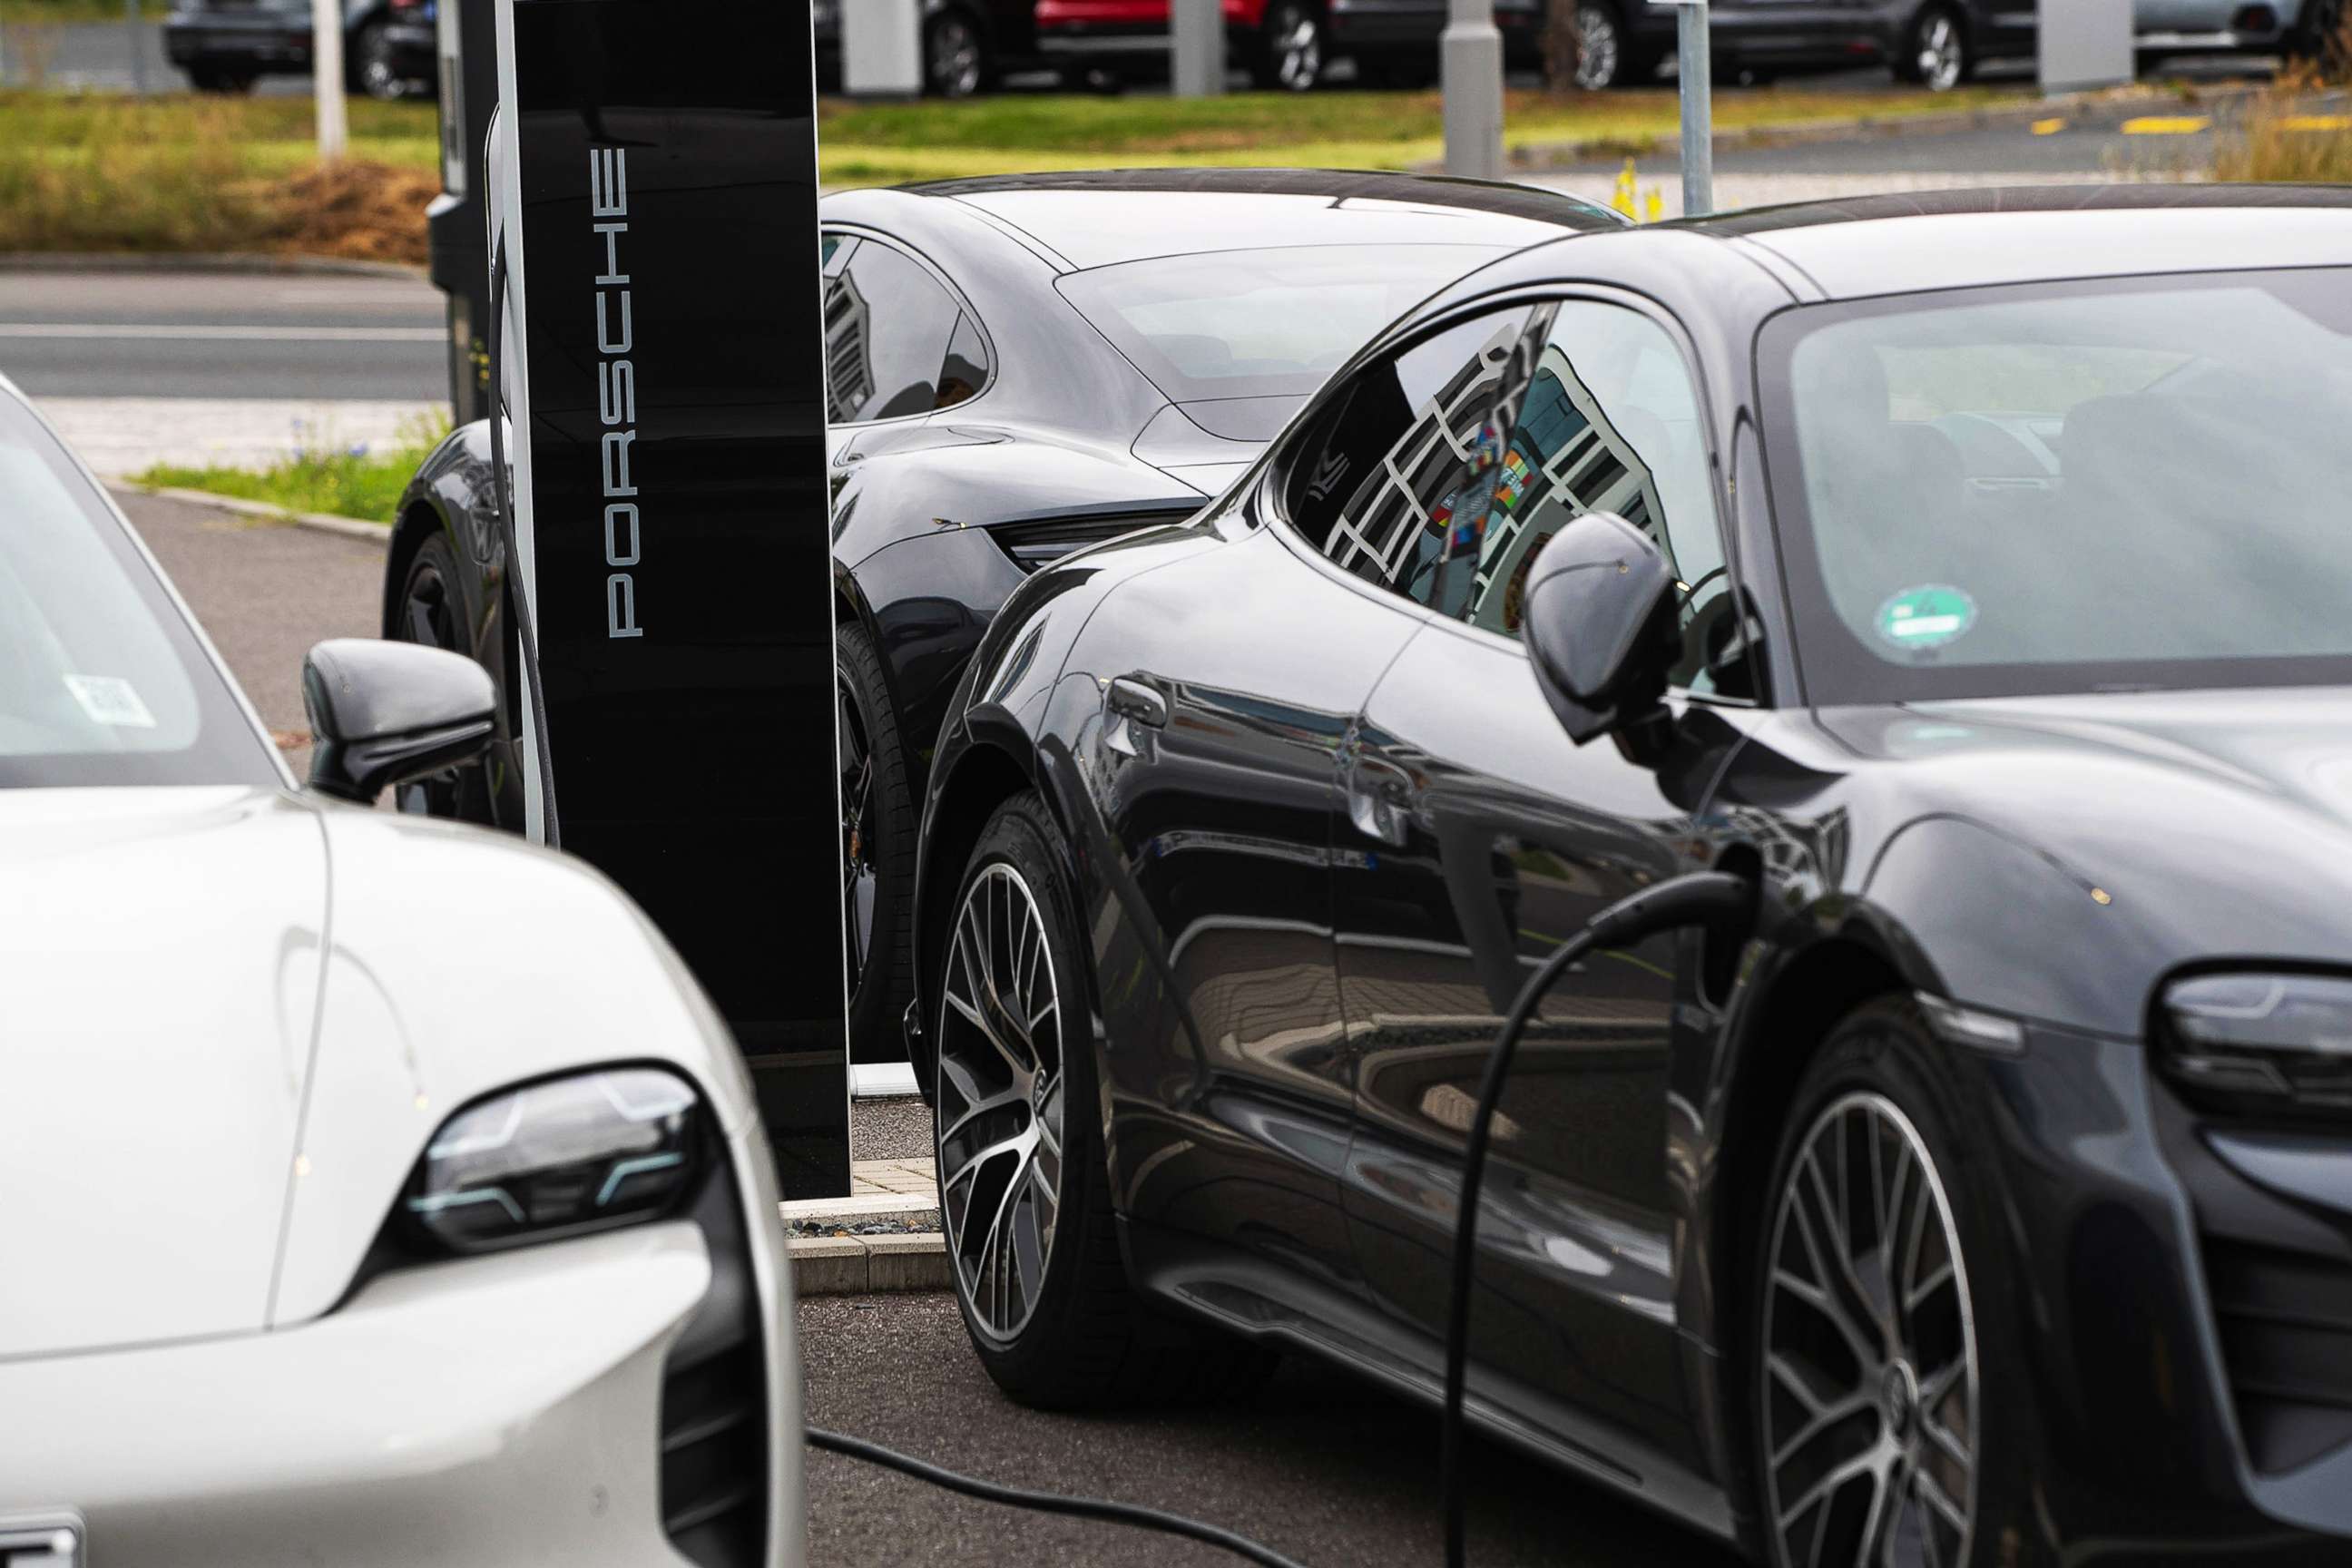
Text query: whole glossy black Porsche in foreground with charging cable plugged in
917 188 2352 1568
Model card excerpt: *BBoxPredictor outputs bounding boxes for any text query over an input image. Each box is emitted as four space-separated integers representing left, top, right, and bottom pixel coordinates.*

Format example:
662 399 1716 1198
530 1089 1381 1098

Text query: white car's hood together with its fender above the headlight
0 789 752 1361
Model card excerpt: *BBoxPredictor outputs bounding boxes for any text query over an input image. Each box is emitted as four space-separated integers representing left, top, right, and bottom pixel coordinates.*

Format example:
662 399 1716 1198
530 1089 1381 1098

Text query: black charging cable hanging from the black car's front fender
1437 872 1757 1568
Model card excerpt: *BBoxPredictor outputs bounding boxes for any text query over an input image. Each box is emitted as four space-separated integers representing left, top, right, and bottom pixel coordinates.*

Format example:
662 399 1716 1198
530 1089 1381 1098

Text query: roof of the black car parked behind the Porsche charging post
898 170 1625 268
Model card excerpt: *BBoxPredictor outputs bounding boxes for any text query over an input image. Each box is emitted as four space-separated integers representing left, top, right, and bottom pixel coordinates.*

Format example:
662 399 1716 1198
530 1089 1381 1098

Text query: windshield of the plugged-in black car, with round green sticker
1761 268 2352 703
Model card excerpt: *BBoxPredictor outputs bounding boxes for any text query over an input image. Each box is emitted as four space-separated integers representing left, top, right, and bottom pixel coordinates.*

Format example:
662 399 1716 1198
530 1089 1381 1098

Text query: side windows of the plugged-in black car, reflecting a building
1289 301 1748 696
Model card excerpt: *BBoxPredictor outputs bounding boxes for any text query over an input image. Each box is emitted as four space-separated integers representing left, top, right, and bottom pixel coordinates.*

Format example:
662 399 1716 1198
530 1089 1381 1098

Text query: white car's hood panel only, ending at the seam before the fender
0 789 327 1358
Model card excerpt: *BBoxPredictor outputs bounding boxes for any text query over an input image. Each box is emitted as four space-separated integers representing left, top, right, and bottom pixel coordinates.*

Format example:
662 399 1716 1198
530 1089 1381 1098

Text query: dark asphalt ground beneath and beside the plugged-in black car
798 1295 1738 1568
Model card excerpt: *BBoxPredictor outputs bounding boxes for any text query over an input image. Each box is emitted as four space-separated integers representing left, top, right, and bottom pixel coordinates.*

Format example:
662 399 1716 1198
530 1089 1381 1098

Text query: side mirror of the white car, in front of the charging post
301 637 499 807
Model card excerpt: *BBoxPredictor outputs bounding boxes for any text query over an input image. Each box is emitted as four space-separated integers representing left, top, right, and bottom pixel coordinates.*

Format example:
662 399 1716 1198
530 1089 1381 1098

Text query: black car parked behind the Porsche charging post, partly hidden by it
383 170 1622 1063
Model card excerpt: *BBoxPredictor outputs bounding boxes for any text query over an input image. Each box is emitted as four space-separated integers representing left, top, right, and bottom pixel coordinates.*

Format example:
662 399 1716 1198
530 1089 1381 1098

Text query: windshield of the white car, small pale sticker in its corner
0 390 282 788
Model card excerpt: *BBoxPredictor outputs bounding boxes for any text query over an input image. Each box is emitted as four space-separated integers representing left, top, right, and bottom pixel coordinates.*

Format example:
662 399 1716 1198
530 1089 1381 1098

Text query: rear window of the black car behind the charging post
1061 244 1507 402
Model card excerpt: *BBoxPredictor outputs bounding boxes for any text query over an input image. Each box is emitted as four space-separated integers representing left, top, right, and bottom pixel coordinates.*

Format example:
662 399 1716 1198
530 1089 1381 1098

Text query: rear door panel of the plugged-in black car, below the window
1061 531 1418 1279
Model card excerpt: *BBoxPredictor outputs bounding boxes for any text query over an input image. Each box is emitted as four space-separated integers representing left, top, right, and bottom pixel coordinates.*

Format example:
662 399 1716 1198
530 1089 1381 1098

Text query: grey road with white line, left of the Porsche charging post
0 270 449 402
